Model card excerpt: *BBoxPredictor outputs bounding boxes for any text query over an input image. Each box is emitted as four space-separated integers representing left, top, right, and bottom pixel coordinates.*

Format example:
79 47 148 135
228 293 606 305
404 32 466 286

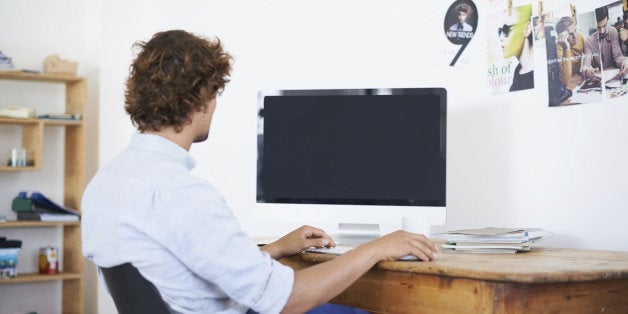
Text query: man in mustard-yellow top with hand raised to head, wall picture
555 16 584 86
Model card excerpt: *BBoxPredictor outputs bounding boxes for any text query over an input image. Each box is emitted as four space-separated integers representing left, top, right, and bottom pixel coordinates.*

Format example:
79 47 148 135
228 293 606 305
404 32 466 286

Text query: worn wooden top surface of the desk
300 248 628 283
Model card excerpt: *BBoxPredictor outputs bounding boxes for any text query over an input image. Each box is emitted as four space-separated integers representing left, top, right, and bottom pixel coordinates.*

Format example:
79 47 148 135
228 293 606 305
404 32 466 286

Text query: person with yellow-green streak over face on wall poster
497 4 534 92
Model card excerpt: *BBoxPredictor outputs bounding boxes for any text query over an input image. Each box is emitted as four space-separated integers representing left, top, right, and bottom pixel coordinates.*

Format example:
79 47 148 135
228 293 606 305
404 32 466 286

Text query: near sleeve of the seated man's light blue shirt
155 183 294 313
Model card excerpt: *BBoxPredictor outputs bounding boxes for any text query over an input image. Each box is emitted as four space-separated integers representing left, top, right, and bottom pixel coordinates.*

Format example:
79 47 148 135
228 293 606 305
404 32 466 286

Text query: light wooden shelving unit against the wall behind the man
0 71 87 314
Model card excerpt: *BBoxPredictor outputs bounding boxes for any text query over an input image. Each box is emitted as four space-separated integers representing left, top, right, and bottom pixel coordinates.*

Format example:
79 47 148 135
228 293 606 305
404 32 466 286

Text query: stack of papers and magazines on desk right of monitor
436 227 547 253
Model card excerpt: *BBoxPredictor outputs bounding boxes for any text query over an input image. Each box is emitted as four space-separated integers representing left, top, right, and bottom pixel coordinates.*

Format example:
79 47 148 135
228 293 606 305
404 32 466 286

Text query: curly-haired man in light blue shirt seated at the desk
81 30 438 313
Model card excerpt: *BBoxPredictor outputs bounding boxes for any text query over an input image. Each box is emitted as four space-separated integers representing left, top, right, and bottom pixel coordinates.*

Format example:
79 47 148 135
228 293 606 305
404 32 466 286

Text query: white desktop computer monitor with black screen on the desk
255 88 447 240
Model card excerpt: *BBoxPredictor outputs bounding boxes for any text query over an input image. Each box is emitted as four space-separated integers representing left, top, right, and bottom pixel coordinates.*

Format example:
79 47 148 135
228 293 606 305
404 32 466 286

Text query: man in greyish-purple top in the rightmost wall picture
582 6 628 82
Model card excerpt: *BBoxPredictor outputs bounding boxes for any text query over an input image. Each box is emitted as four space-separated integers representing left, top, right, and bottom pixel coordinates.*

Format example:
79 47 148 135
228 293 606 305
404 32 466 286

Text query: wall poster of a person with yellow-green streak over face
487 4 534 94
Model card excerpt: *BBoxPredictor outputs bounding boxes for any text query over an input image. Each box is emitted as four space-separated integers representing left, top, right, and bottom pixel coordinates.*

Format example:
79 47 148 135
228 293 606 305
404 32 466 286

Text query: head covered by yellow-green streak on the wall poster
497 5 534 58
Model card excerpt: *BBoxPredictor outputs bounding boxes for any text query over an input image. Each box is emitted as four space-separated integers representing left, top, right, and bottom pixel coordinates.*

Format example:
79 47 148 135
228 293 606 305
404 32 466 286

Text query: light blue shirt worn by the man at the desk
81 134 294 313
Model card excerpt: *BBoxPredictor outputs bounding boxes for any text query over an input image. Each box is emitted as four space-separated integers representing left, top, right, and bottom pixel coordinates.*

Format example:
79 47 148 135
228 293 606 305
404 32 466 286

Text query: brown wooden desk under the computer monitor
281 248 628 313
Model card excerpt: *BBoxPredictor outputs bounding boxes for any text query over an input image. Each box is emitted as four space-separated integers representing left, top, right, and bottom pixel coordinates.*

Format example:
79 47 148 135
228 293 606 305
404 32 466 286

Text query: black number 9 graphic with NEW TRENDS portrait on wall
444 0 478 66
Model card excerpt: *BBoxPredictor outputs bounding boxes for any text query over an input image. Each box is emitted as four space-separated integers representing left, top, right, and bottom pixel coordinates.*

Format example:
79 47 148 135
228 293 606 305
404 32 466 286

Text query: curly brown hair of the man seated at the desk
124 30 232 132
